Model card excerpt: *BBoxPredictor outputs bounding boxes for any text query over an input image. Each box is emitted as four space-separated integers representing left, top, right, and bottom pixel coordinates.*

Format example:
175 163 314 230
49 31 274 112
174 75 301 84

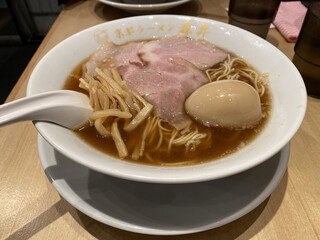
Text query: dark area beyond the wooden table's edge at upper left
0 0 64 104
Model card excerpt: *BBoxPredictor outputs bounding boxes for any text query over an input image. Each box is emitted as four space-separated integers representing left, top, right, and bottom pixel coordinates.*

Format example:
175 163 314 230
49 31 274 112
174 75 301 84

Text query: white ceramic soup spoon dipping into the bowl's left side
0 90 92 128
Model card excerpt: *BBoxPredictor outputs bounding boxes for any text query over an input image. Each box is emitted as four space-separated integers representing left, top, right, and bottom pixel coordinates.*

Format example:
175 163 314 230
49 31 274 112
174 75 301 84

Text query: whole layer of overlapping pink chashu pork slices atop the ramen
84 36 227 130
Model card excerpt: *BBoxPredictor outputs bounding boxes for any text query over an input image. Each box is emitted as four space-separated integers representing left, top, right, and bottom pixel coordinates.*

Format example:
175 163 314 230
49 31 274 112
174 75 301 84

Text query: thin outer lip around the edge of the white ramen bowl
27 14 307 183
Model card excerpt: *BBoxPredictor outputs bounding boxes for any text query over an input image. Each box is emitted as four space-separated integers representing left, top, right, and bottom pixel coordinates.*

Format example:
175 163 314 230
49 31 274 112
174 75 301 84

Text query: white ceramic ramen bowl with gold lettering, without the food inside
27 15 307 183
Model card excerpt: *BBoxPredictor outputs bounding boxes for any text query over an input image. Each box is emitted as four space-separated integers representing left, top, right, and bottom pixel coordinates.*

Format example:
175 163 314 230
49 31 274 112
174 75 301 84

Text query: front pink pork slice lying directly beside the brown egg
119 58 208 130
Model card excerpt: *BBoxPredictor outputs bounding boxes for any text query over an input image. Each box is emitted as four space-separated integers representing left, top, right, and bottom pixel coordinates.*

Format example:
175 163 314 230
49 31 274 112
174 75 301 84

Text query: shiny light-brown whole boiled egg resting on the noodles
185 80 262 128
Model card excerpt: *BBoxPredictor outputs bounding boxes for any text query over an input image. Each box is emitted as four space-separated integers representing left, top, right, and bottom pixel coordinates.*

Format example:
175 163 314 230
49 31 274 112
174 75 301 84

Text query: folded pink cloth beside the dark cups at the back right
273 1 307 42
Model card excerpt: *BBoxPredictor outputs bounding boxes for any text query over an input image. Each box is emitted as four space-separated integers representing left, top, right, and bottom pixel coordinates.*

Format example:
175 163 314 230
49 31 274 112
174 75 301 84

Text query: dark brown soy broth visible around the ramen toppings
63 55 271 165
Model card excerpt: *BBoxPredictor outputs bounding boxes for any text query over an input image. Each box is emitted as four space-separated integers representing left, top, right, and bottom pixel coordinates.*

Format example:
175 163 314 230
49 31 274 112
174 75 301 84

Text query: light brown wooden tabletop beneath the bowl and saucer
0 0 320 240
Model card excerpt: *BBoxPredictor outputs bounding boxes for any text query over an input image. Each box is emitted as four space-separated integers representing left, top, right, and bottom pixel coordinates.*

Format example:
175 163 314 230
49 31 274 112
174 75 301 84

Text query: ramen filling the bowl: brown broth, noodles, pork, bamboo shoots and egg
64 36 271 166
